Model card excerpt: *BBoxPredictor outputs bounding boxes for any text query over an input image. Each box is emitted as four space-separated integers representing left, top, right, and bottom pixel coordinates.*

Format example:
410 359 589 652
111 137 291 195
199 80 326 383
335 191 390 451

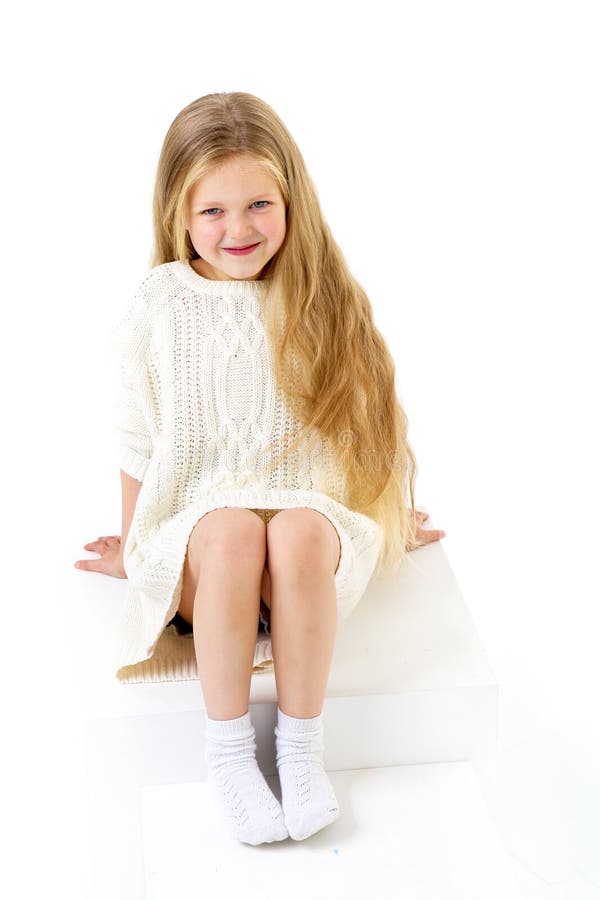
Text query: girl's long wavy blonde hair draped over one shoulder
152 92 417 570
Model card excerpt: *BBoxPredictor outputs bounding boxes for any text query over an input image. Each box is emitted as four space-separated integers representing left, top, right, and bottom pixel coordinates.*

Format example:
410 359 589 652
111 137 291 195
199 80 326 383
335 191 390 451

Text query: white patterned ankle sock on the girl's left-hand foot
205 711 288 844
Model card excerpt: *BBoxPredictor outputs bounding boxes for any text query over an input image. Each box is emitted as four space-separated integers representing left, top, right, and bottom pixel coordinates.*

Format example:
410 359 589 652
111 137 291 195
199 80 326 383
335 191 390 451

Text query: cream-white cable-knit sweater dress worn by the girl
111 261 383 679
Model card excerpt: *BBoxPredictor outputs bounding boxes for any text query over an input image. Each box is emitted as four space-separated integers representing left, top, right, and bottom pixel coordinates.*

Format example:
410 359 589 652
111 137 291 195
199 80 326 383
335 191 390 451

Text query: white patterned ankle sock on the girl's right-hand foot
275 707 339 841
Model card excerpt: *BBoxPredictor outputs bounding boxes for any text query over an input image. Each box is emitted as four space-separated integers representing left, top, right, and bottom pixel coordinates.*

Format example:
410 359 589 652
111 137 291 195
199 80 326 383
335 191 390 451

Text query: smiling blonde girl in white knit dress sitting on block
75 92 444 844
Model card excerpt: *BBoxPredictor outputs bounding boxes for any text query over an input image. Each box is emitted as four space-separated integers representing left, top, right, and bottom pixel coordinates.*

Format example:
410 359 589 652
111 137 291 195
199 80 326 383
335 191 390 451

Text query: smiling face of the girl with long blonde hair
185 154 286 281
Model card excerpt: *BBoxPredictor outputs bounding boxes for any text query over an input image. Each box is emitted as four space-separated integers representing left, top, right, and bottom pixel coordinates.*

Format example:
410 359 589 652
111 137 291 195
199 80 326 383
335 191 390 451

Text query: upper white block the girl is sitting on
79 543 498 778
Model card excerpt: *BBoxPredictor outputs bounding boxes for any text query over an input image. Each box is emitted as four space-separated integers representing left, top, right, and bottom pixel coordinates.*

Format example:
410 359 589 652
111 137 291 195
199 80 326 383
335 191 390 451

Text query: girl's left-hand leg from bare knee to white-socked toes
180 509 288 844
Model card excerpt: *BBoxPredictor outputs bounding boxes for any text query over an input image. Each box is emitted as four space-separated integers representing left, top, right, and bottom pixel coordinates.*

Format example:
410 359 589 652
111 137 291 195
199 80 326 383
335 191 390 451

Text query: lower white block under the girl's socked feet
141 763 521 900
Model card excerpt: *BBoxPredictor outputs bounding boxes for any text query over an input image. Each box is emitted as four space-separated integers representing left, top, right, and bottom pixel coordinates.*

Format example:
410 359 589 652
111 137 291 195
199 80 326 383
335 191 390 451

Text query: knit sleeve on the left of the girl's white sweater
111 295 153 481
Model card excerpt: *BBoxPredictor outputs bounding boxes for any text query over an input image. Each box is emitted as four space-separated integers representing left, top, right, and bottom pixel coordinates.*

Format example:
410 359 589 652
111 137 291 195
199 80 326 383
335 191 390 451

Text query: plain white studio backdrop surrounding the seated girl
1 0 600 897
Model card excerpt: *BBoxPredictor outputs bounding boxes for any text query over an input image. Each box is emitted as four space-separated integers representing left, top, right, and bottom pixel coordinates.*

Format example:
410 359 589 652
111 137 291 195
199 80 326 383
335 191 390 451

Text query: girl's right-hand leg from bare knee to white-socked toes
267 509 340 841
